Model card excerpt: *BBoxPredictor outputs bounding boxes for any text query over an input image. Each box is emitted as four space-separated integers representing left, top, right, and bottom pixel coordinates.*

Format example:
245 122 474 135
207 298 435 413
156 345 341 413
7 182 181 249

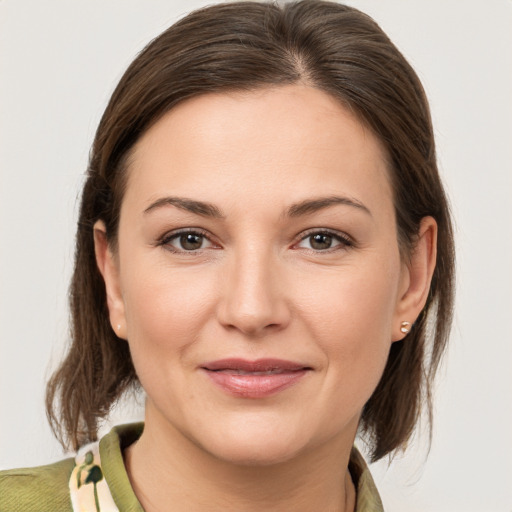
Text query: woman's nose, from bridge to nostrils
214 247 291 338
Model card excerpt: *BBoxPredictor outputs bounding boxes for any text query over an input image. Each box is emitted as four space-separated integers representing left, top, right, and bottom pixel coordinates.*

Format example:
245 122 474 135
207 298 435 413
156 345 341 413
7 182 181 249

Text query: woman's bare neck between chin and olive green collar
125 414 355 512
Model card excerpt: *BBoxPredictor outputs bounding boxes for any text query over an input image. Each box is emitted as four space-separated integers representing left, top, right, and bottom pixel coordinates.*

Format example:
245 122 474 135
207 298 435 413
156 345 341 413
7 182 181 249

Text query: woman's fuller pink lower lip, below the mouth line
204 369 308 398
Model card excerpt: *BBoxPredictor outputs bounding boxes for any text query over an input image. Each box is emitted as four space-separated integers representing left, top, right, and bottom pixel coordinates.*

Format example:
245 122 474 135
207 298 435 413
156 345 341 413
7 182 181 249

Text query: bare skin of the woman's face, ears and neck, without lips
95 85 436 512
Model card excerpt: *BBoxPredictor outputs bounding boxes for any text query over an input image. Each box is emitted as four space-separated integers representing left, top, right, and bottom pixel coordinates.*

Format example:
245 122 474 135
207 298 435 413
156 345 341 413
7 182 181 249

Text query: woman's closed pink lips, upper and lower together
201 359 312 398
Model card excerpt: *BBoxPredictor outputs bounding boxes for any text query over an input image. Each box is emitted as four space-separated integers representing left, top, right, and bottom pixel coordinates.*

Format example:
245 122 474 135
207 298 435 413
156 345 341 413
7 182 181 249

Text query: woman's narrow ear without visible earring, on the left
93 220 126 339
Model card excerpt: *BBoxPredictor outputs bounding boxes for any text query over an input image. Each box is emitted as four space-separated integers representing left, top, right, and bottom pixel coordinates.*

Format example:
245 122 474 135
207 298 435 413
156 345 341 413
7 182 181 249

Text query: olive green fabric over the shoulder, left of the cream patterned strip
0 458 75 512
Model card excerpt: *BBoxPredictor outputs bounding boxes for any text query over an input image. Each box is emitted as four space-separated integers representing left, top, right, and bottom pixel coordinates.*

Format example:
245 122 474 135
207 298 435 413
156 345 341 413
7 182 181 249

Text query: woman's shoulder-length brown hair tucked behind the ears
47 0 454 460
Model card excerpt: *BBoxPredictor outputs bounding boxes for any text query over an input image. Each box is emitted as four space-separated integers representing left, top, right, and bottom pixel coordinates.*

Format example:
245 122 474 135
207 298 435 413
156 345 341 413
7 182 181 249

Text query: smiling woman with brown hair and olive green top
0 1 453 512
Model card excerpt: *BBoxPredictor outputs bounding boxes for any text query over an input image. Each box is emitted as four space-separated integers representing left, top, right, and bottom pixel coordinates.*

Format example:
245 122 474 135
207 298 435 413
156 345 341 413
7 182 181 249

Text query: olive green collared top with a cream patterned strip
0 423 384 512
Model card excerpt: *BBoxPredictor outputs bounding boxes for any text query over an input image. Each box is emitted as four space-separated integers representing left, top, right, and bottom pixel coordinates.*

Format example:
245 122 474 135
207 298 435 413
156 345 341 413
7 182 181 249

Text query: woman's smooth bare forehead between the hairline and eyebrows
125 85 391 216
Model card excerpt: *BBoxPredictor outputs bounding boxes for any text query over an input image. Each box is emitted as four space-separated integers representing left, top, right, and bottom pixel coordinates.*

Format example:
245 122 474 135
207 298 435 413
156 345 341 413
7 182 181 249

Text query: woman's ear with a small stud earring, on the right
392 217 437 341
